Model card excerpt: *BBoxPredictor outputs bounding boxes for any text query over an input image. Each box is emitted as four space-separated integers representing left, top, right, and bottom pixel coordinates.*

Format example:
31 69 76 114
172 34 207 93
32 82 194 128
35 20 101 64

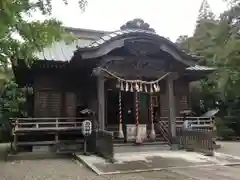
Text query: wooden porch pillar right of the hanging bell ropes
166 74 176 139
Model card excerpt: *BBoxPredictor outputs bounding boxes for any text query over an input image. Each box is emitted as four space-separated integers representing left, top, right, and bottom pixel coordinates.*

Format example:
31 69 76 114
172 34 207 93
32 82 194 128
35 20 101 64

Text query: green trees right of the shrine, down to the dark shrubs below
177 0 240 136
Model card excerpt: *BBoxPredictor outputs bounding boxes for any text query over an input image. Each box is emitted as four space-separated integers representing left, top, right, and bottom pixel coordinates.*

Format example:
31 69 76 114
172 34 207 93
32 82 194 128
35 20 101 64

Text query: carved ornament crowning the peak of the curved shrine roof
120 18 155 32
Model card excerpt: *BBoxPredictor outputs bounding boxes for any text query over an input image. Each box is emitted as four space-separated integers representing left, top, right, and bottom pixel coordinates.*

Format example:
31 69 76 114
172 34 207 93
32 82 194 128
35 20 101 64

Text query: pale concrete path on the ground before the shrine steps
76 151 240 175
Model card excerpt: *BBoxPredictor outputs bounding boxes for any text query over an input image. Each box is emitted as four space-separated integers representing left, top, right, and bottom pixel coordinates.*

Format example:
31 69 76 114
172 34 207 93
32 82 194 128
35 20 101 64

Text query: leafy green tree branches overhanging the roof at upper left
0 0 86 64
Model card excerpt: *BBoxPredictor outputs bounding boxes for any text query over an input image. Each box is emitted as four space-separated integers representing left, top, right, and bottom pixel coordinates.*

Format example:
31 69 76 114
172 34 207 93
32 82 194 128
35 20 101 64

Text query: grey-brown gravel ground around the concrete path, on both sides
0 142 240 180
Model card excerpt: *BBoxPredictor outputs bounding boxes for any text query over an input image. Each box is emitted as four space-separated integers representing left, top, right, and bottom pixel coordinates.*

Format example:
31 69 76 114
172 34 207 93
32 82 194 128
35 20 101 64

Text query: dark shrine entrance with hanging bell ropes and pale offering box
105 75 160 143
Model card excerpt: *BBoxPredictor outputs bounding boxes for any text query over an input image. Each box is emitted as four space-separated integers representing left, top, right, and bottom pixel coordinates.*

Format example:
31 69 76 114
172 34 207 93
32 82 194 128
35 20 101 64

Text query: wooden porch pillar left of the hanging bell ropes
97 74 105 130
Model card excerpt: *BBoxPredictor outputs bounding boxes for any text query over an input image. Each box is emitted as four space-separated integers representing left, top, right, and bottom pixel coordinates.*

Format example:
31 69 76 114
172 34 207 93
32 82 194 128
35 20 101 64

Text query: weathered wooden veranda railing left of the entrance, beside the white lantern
11 117 94 152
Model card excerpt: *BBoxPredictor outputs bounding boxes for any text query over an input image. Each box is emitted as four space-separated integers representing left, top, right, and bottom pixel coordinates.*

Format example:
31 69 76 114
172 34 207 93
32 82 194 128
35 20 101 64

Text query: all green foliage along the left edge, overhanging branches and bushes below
0 0 87 142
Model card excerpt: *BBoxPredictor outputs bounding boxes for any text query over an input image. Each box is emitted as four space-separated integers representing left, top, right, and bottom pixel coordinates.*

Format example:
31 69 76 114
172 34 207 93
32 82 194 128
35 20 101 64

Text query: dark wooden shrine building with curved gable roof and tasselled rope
14 20 214 152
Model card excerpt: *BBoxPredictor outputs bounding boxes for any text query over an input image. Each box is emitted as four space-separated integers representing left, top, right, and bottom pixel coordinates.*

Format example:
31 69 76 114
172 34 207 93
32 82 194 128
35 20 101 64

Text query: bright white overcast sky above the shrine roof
33 0 226 41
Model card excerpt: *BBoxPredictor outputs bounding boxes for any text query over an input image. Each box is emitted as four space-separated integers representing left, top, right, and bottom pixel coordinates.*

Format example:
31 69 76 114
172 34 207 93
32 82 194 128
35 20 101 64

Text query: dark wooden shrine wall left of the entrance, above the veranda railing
34 71 97 117
